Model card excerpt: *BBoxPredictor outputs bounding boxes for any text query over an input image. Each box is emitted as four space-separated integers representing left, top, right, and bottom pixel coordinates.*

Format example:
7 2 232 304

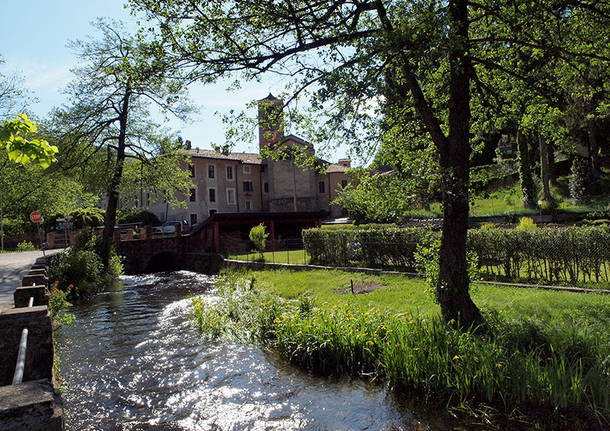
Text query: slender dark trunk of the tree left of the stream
101 85 131 267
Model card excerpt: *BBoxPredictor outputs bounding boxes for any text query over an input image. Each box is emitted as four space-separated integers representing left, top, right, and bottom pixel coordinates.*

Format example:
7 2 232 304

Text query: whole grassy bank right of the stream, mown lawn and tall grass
193 271 610 430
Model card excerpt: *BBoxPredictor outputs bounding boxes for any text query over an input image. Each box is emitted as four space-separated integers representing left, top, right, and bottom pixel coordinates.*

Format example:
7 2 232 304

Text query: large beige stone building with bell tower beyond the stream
145 94 350 226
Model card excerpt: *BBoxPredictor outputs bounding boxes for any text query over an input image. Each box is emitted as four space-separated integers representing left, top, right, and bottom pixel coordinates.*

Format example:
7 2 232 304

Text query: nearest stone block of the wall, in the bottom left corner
0 379 64 431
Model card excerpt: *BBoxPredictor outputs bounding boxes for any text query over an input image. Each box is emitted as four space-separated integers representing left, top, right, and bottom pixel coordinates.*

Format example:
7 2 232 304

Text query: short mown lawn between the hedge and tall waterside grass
251 270 610 336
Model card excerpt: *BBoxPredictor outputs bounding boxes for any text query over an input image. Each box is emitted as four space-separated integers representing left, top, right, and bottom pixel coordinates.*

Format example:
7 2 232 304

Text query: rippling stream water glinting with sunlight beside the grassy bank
56 271 436 430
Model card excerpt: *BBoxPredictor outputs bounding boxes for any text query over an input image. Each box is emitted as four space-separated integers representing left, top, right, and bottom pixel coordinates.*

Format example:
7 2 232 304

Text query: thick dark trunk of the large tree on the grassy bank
436 0 483 327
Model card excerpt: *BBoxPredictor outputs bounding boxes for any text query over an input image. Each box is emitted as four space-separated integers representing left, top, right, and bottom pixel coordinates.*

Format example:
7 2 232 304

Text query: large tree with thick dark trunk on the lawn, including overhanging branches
130 0 607 326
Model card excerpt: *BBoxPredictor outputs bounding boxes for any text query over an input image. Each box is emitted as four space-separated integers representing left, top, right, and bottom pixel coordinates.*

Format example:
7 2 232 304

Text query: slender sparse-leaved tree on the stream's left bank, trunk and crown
56 20 189 265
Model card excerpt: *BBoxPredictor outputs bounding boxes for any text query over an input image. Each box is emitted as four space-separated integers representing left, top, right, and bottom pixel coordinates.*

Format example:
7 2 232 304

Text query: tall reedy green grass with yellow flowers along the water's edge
192 272 610 429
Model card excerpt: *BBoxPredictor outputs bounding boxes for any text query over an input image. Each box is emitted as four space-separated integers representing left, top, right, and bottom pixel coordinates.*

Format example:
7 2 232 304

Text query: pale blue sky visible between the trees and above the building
0 0 346 162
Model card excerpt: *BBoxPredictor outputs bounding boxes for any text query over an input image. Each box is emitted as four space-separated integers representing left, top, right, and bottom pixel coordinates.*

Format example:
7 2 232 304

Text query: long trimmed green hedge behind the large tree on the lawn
303 227 610 283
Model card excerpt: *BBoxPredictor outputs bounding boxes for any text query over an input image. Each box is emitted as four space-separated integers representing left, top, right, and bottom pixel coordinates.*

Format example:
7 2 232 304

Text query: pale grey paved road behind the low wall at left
0 250 62 310
